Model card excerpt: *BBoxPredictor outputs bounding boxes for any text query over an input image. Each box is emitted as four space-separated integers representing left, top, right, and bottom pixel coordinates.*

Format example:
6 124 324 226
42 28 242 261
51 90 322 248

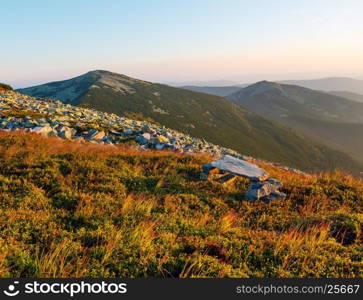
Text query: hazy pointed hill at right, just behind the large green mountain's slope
228 81 363 161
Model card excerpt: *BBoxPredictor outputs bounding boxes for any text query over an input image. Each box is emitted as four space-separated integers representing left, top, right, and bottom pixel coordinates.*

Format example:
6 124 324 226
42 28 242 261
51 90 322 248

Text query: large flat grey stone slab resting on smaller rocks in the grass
203 155 269 181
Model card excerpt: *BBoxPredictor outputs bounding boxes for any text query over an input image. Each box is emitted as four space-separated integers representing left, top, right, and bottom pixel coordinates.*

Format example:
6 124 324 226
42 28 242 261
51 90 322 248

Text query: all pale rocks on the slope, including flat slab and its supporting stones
0 90 303 202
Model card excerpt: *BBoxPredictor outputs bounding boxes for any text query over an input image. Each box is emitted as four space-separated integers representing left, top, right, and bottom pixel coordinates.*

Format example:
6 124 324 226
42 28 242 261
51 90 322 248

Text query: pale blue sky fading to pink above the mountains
0 0 363 88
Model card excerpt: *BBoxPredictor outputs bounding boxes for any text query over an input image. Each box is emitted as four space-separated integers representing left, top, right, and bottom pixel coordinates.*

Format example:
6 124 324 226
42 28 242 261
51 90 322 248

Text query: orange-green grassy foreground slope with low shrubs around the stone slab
0 132 363 277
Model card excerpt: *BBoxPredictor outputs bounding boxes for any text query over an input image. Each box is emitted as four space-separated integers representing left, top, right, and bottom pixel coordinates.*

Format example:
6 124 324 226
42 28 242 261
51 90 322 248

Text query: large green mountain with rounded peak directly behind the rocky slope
15 71 362 171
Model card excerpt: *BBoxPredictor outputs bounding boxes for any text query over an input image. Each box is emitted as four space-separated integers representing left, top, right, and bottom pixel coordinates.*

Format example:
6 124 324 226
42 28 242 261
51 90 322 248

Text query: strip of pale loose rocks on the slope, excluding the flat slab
0 90 243 158
